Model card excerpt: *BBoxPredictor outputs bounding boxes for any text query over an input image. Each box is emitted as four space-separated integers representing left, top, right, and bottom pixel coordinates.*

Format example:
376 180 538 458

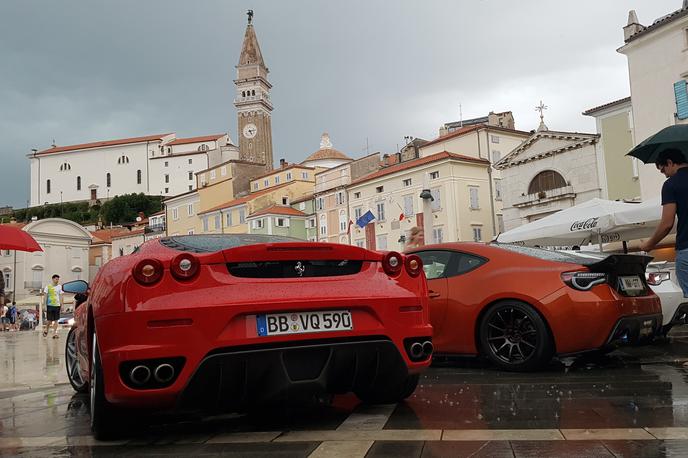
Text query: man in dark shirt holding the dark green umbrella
640 149 688 297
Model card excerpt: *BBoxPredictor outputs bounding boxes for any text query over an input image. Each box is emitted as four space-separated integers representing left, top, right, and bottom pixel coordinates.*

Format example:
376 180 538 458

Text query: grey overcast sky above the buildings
0 0 681 208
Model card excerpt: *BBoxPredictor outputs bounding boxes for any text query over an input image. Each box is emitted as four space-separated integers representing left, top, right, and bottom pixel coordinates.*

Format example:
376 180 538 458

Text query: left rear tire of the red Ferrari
89 333 124 440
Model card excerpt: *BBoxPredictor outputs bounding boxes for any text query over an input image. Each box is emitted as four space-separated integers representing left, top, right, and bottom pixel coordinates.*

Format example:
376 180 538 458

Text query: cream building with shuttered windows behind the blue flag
347 151 494 250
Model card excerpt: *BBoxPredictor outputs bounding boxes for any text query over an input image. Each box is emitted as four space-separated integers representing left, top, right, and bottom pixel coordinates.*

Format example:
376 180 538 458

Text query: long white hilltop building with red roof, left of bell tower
28 133 239 207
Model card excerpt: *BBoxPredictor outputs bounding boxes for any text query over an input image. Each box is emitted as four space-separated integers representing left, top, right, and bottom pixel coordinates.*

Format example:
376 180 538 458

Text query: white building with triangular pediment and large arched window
495 124 604 231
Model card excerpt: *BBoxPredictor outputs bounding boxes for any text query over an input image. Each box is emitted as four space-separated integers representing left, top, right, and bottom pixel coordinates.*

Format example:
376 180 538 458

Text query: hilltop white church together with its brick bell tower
27 15 273 207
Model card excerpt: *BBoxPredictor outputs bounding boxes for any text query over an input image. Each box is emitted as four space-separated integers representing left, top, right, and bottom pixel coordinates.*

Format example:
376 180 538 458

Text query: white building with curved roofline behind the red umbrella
0 218 91 301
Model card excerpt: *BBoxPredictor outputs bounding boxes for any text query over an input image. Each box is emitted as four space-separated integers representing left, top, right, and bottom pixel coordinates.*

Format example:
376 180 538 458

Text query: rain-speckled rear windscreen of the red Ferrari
160 234 303 253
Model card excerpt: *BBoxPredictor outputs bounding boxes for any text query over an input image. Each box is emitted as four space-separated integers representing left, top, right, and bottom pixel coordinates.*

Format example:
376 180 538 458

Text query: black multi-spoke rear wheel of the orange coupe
478 301 554 372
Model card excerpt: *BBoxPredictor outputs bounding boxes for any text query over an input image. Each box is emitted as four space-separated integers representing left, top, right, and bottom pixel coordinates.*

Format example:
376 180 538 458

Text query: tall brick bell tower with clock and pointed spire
234 10 273 171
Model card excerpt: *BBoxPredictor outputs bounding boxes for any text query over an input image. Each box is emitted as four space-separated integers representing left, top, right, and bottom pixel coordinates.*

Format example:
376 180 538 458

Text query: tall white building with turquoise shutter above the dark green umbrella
618 1 688 200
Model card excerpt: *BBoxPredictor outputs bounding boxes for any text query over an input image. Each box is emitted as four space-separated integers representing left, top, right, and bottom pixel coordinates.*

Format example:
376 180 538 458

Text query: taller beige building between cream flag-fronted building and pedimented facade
420 123 530 234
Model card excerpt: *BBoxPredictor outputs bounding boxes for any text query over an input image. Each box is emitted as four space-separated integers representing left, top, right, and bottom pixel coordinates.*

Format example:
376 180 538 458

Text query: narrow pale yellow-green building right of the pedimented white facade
583 97 640 200
